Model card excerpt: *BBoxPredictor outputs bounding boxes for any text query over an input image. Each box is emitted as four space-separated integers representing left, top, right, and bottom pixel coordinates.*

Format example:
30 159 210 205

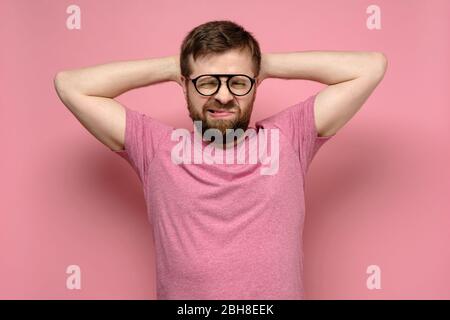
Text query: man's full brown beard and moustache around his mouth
187 94 256 141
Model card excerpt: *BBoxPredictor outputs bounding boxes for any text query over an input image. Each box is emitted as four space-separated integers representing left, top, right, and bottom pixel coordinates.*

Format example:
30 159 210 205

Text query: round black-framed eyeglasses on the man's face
189 74 255 96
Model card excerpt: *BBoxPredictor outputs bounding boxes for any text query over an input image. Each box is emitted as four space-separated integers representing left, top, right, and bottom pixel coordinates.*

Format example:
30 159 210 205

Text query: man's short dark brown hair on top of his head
180 20 261 78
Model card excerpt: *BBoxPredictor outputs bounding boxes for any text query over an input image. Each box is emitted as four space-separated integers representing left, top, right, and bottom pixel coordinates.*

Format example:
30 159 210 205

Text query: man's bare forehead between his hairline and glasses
189 49 253 77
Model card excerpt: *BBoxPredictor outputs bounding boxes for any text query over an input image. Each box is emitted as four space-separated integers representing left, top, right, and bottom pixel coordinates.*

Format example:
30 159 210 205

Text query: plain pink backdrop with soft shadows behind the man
0 0 450 299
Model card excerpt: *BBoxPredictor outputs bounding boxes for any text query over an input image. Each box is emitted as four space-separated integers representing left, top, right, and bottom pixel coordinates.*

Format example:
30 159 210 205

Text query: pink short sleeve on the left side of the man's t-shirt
111 106 171 184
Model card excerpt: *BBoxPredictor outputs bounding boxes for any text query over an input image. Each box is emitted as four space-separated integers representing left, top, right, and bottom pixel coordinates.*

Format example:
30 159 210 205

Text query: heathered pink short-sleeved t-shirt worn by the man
111 94 334 300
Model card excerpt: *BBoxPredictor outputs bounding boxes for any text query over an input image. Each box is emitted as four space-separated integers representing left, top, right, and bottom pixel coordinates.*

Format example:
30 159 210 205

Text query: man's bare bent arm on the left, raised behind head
54 55 180 150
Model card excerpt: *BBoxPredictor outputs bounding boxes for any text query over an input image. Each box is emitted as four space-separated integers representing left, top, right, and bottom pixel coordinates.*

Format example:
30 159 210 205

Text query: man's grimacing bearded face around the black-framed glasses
181 50 259 135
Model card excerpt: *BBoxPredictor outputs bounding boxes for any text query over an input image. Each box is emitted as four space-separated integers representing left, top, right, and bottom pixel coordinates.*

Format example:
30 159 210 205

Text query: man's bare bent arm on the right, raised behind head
260 51 388 136
